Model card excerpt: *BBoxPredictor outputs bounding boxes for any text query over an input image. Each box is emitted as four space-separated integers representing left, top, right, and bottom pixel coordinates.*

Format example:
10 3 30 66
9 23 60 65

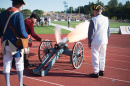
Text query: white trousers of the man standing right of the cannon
91 44 107 74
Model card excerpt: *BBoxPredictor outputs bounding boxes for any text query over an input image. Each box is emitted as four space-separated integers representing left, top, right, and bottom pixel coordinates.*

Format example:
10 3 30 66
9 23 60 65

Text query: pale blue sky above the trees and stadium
0 0 130 12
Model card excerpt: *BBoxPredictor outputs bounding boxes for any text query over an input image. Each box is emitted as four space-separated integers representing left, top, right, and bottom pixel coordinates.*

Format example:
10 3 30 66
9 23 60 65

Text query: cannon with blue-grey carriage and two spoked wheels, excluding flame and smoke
33 37 84 76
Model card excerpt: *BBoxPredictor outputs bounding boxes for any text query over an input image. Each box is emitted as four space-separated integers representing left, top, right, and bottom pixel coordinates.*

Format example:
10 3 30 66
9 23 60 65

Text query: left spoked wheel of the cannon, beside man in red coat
38 39 53 62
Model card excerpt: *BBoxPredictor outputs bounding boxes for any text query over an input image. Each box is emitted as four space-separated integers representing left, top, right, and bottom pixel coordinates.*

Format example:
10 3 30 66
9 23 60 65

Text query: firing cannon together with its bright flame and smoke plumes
33 21 89 76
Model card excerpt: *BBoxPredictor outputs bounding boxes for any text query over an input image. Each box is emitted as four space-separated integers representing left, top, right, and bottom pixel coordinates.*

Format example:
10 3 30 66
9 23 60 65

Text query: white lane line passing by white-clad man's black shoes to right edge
52 67 130 83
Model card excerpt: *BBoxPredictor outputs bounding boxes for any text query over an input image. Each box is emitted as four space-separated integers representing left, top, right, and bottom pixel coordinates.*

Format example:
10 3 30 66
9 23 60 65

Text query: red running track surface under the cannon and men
0 34 130 86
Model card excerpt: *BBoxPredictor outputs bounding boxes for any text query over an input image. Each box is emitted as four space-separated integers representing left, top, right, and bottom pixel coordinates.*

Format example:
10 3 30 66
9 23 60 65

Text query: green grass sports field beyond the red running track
34 21 130 34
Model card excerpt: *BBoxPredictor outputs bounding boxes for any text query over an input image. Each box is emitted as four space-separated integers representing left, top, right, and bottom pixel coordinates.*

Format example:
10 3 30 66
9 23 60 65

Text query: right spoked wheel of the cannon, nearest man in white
72 42 84 69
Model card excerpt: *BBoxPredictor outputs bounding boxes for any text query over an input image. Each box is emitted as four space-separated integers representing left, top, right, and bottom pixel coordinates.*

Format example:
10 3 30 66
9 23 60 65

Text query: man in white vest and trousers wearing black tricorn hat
88 5 110 78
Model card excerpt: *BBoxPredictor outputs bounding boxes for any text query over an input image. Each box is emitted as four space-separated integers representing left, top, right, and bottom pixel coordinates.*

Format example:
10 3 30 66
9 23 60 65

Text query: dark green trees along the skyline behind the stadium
0 0 130 20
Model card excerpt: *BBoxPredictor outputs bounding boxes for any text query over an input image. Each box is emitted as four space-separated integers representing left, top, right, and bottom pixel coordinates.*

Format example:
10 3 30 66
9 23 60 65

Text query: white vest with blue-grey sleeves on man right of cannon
88 14 110 45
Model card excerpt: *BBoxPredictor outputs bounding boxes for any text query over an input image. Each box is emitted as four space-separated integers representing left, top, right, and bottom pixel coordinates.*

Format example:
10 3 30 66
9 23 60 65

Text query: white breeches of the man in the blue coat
3 46 24 73
